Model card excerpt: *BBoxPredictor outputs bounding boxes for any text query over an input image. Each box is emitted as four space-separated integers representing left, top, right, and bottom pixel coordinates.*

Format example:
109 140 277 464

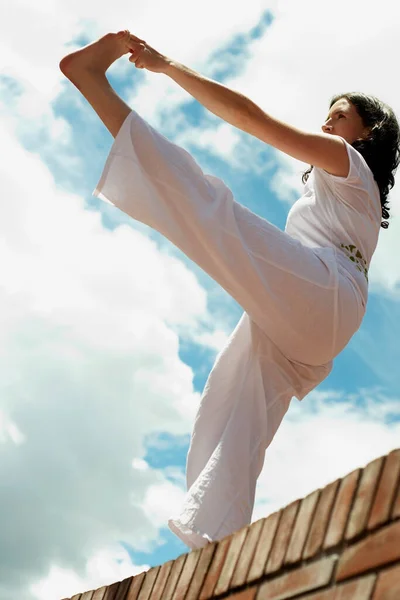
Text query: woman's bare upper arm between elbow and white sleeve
241 109 350 177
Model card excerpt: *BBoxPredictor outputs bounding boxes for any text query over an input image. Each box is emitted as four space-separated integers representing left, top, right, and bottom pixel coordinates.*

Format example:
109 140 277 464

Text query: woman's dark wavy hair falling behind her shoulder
302 92 400 229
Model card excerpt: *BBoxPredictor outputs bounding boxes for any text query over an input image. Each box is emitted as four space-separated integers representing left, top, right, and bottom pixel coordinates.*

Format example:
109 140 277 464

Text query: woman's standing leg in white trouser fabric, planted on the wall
168 313 294 549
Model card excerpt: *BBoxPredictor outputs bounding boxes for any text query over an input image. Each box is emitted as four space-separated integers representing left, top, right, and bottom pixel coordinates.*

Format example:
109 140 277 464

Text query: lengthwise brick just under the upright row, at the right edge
336 521 400 581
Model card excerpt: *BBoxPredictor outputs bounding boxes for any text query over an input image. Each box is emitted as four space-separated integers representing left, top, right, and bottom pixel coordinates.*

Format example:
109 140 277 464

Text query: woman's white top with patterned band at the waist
285 138 382 304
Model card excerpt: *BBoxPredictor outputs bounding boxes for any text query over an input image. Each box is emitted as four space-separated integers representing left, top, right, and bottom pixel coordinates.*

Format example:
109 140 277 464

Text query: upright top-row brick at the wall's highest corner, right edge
368 450 400 529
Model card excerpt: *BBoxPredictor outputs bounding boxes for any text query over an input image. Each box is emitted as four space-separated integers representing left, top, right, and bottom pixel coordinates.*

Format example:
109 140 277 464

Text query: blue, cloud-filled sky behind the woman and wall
0 0 400 600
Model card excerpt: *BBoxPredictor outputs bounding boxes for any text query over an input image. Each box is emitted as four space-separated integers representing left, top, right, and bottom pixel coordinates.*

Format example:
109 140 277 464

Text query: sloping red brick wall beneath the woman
61 449 400 600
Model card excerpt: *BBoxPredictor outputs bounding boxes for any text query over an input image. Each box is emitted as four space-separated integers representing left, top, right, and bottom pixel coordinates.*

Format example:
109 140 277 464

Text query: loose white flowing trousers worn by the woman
94 111 364 548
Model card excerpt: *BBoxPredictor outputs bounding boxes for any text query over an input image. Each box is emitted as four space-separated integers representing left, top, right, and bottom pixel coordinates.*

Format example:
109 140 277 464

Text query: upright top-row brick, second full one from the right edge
344 457 385 541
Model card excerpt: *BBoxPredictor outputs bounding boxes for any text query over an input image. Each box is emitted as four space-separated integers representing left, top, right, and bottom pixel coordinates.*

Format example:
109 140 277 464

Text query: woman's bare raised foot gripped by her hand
60 31 130 85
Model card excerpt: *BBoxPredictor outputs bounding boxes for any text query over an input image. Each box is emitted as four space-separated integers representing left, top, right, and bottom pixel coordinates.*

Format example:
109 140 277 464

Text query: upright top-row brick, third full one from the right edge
323 469 361 550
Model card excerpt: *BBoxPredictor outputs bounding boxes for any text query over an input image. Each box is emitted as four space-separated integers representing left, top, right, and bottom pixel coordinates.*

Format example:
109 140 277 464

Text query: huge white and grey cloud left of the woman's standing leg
0 105 217 600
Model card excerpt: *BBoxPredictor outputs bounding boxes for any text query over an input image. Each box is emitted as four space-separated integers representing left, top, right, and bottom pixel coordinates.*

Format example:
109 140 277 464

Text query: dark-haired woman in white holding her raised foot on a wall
60 31 400 548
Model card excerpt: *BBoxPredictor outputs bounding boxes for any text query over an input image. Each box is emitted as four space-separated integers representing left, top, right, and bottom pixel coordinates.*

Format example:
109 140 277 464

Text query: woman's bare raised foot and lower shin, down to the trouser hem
60 31 131 137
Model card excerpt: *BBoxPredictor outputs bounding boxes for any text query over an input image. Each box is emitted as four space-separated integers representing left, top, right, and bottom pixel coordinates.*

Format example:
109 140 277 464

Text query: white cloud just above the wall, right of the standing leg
252 390 400 521
